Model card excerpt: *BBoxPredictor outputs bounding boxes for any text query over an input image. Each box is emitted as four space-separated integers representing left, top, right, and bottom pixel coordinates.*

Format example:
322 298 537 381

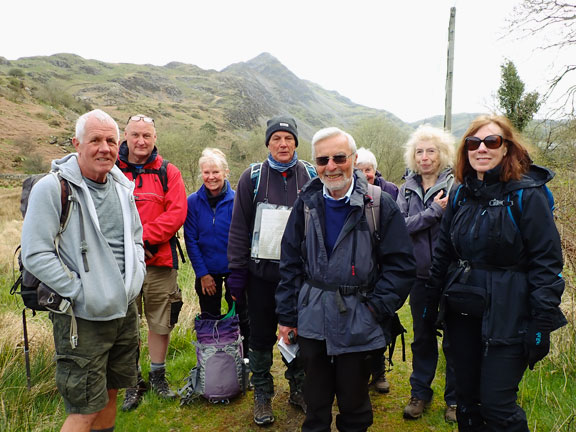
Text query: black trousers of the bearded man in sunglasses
298 336 373 432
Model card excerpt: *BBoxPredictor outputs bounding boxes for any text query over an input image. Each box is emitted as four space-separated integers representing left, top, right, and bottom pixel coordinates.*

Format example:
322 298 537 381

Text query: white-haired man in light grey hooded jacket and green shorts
22 110 146 432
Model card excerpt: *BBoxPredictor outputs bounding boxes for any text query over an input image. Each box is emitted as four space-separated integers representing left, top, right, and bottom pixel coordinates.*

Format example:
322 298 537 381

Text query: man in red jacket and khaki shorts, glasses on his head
117 114 187 411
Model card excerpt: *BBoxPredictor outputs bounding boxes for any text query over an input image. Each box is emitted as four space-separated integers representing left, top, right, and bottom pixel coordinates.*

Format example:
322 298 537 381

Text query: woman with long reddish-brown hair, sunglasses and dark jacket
424 116 566 432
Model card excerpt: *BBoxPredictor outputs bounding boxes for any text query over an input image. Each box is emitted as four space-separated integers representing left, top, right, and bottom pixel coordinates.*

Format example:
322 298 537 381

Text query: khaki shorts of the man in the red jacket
136 266 182 335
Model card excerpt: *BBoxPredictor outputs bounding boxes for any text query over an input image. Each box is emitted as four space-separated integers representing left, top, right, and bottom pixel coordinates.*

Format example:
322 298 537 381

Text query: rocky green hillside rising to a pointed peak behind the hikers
0 53 402 172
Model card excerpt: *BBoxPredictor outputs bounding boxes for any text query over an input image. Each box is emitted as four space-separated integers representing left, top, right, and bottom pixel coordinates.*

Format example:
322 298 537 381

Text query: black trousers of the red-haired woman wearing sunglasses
446 313 529 432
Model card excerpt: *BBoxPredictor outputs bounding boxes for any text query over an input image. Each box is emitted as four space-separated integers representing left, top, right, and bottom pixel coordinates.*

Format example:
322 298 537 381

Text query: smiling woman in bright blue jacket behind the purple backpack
184 148 248 357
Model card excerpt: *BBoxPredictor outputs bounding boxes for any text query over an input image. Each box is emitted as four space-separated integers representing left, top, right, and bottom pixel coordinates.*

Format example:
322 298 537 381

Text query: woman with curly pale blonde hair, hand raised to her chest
396 125 456 422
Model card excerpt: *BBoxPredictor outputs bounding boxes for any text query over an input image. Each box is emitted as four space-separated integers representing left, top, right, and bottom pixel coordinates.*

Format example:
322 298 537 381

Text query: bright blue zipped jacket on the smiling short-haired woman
184 180 234 278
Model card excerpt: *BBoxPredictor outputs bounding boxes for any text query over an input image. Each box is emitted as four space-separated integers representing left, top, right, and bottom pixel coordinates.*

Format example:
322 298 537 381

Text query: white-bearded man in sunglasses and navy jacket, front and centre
276 128 415 432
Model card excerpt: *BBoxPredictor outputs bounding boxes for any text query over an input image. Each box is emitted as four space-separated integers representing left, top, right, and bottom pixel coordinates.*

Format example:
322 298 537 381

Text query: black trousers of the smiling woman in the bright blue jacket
194 273 250 358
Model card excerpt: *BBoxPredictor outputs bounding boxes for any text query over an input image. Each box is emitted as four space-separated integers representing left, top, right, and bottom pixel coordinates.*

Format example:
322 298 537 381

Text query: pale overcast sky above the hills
0 0 576 121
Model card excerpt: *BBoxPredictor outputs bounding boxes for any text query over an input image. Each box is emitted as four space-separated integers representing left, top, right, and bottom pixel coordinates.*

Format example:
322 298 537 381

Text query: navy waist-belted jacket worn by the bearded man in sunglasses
276 171 416 355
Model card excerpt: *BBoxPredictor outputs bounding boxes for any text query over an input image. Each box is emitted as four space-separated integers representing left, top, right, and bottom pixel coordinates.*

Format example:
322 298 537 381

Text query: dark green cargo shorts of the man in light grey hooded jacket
50 302 139 414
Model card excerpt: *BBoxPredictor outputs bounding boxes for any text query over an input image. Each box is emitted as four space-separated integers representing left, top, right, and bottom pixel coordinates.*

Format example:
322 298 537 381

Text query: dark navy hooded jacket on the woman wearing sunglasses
428 165 566 346
